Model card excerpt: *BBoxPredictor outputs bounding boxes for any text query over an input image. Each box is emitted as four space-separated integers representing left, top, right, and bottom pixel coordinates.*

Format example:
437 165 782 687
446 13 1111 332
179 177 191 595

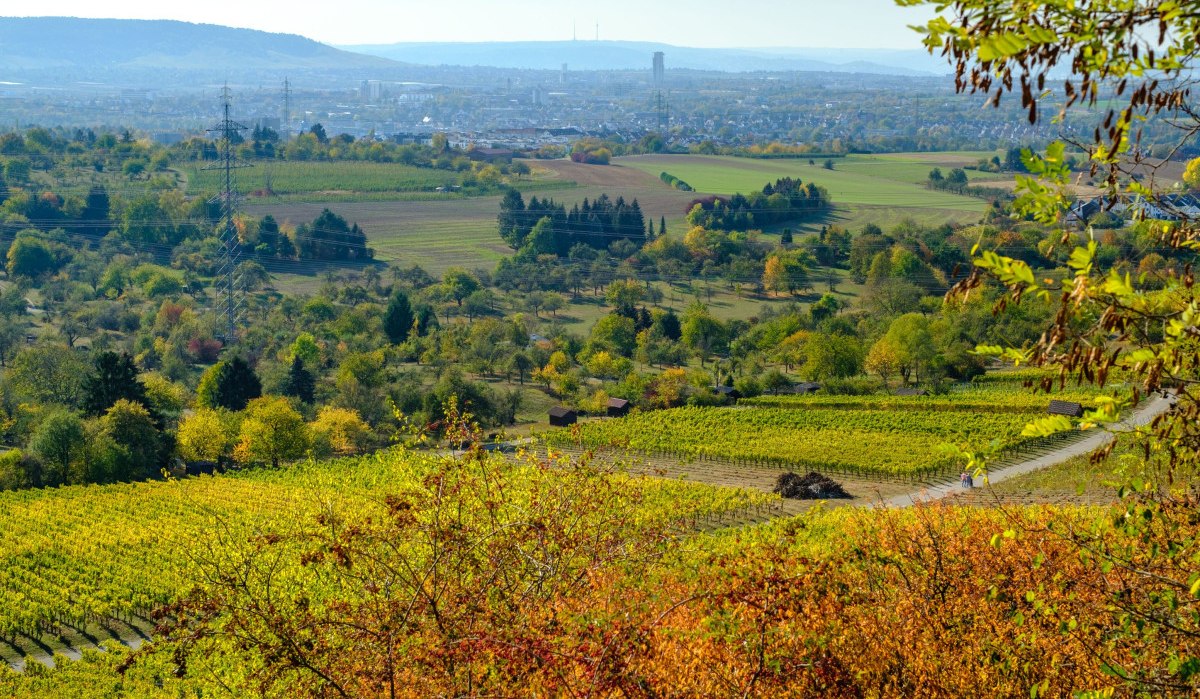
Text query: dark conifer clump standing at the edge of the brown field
497 190 648 257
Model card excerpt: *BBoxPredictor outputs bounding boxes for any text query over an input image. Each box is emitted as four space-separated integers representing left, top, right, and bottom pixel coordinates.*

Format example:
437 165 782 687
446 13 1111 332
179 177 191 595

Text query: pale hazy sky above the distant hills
11 0 931 48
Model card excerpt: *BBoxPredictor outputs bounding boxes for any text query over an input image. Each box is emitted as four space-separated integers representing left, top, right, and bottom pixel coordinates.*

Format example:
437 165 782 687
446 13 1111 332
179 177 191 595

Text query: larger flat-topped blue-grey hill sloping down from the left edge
0 17 402 79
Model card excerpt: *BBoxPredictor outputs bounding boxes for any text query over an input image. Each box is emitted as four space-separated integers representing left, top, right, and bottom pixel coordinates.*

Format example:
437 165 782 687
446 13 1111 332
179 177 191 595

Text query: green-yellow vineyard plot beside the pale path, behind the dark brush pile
547 396 1065 479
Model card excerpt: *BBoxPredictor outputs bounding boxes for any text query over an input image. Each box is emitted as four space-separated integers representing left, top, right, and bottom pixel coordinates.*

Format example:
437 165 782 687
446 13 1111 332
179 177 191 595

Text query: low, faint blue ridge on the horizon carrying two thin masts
342 41 949 76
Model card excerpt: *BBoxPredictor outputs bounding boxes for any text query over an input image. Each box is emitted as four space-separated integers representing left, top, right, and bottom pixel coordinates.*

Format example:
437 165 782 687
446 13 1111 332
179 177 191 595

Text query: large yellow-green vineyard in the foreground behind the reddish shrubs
0 444 774 661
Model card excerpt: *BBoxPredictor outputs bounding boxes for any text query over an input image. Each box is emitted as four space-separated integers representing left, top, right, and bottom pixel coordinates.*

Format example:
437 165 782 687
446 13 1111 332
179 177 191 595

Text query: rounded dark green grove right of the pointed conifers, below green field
688 178 829 231
